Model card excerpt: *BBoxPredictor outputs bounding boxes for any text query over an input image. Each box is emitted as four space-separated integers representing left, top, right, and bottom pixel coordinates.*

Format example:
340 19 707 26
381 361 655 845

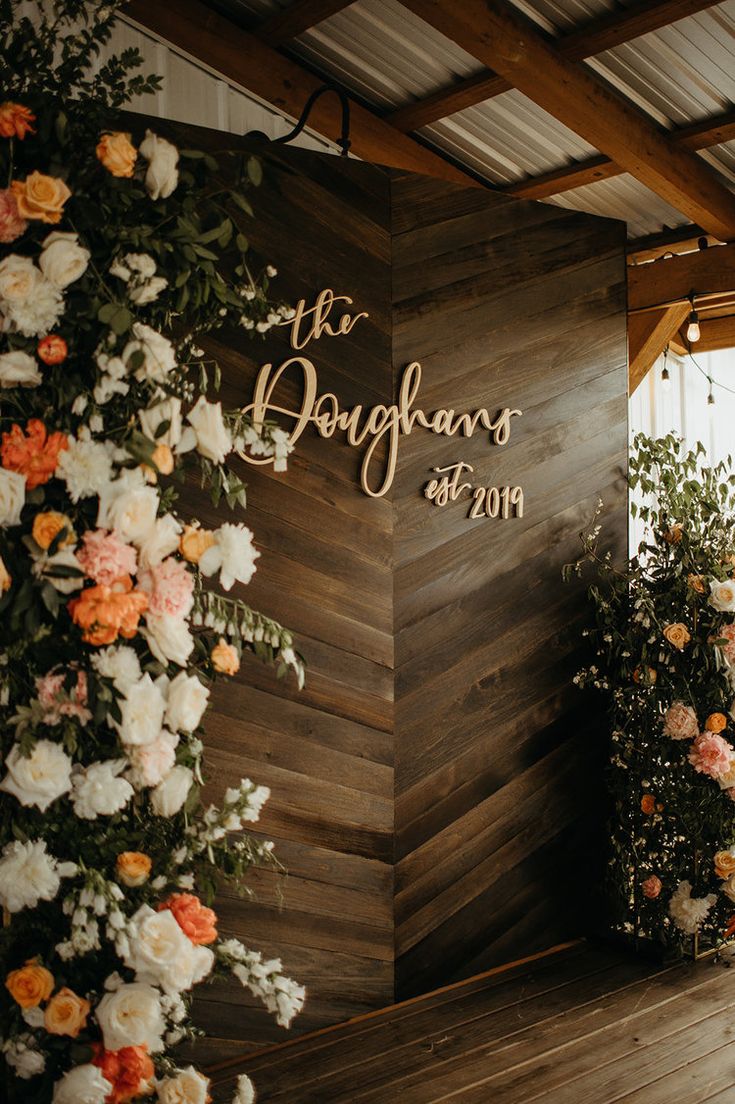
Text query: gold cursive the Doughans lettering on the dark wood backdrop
241 288 522 498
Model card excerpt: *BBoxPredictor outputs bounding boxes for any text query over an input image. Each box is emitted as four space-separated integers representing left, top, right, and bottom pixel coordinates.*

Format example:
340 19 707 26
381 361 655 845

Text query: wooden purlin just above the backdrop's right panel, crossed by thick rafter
503 109 735 200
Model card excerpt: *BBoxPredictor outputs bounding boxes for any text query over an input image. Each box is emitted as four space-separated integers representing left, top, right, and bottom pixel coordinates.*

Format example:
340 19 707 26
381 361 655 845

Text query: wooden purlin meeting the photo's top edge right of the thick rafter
387 0 716 132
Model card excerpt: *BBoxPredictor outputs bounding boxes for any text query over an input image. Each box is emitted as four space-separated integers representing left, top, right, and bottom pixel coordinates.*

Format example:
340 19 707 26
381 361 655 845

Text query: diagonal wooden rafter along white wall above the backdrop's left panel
124 0 474 188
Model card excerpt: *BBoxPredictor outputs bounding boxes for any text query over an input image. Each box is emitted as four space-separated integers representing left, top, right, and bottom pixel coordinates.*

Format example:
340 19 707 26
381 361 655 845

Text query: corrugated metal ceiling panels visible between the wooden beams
203 0 735 236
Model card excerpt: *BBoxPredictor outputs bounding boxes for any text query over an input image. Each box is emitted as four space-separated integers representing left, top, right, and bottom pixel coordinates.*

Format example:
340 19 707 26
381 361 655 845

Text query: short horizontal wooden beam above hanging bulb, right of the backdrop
627 245 735 311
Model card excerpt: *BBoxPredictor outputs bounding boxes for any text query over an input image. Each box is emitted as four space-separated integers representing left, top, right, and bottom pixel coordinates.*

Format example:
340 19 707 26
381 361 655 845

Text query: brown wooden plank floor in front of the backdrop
204 943 735 1104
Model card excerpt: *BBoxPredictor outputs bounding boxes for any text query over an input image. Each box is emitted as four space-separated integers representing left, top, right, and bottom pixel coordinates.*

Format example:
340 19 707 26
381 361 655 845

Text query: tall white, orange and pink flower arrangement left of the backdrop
0 0 303 1104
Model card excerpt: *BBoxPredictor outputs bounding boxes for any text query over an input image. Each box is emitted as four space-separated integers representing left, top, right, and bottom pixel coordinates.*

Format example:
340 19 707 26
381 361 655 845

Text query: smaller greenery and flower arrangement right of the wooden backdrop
575 435 735 954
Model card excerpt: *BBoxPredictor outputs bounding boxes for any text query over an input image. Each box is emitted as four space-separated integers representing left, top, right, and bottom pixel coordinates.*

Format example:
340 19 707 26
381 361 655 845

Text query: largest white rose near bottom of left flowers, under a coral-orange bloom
125 904 214 992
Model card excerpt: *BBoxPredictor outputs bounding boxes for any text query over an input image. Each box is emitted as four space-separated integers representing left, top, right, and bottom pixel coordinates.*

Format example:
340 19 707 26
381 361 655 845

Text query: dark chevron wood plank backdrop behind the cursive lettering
143 121 627 1060
